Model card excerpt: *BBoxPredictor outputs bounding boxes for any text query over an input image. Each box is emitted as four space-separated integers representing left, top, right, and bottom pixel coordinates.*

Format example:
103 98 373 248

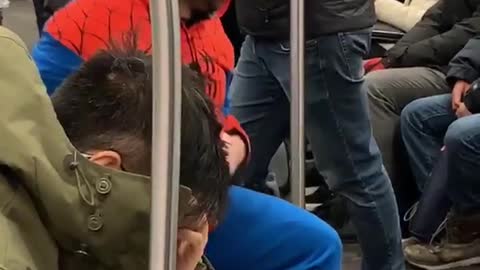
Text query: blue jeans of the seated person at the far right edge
401 94 480 212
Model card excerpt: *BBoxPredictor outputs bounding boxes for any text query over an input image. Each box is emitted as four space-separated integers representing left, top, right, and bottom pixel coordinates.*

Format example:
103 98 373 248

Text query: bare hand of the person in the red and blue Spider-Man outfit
220 132 247 175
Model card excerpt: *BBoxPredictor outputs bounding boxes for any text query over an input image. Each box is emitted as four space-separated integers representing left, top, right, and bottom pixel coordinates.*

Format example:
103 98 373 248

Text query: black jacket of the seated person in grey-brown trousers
384 0 480 70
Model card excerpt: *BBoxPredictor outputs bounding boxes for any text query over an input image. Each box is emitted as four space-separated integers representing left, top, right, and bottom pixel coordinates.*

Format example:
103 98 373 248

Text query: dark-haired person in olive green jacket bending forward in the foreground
0 27 227 270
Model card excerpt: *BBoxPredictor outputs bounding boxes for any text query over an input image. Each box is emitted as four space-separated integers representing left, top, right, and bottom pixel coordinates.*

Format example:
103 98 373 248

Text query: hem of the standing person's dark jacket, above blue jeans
235 0 376 40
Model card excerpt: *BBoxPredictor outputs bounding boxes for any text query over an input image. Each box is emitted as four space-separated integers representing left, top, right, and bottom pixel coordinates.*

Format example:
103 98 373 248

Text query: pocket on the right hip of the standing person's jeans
338 29 371 81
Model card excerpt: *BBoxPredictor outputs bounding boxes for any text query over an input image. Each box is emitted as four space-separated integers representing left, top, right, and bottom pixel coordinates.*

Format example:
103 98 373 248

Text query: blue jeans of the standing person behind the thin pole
231 33 404 270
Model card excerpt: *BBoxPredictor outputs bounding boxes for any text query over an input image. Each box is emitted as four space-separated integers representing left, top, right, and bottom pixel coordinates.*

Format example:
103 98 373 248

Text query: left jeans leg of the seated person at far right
401 94 457 190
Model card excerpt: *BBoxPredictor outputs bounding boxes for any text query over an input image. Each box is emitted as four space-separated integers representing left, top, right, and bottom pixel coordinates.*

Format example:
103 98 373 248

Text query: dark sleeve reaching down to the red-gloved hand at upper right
384 0 444 67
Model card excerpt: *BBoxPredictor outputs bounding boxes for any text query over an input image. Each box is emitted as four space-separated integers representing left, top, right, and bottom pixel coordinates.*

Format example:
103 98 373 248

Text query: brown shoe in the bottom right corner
404 215 480 270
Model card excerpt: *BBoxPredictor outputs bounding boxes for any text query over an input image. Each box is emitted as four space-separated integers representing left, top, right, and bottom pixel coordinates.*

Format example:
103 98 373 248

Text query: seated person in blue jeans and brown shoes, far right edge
401 34 480 269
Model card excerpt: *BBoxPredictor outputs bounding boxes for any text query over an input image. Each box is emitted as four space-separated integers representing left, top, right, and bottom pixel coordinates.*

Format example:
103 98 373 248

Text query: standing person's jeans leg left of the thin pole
230 36 290 192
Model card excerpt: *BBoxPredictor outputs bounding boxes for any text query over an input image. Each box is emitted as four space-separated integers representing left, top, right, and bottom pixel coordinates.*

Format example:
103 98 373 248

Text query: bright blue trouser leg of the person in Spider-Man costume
207 187 342 270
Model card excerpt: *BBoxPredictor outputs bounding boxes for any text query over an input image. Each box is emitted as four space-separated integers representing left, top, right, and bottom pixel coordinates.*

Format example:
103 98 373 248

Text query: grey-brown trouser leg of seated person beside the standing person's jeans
366 67 450 186
